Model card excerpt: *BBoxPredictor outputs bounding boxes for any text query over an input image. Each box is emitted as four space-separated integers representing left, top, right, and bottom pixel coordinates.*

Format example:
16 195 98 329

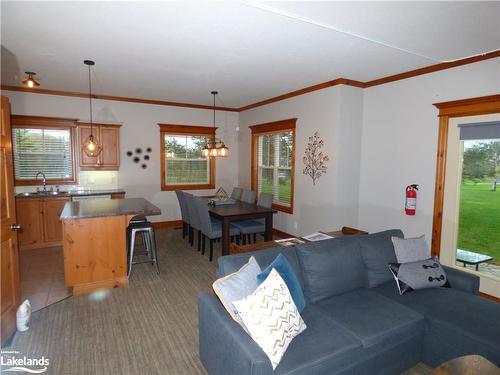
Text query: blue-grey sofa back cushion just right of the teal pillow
296 236 365 303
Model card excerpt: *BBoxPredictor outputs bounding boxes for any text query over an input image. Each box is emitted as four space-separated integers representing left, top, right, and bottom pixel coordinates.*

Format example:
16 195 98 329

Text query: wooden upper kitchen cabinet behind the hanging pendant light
78 122 120 171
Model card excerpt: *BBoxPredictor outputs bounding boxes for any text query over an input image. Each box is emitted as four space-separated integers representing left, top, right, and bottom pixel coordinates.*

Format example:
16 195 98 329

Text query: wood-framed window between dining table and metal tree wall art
250 119 297 213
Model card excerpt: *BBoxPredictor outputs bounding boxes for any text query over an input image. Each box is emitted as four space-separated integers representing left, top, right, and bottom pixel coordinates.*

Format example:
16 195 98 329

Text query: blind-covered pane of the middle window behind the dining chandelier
164 135 210 185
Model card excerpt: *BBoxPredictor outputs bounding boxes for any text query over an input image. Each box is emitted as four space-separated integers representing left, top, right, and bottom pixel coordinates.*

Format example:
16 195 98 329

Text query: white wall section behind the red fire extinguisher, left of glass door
358 58 500 241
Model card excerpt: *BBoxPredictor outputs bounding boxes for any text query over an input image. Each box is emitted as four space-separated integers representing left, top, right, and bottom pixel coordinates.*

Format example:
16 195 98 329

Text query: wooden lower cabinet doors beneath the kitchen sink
16 197 71 250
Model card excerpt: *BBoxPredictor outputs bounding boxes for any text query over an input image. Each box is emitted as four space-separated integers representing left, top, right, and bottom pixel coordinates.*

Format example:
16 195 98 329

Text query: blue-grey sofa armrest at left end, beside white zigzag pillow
198 293 273 375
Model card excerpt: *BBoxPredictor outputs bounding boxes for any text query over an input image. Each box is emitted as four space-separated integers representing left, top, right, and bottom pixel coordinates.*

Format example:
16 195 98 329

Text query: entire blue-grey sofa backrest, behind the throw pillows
217 229 403 303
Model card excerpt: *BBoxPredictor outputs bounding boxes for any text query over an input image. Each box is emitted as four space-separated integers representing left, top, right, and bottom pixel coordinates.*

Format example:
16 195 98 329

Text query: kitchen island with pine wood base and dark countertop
61 198 161 295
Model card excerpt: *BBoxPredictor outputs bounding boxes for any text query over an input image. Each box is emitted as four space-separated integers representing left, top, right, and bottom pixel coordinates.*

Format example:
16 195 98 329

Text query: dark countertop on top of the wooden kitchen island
61 198 161 220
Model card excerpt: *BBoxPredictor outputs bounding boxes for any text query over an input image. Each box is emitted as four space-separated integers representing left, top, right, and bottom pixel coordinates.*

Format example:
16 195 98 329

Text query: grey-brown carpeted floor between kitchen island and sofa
4 229 430 375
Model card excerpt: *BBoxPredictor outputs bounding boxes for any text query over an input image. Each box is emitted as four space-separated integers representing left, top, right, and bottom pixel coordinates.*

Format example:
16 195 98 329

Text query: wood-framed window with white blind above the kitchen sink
12 116 76 185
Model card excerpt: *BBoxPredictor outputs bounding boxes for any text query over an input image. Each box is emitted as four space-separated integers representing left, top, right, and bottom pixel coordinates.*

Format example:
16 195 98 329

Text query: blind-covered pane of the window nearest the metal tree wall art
257 131 293 207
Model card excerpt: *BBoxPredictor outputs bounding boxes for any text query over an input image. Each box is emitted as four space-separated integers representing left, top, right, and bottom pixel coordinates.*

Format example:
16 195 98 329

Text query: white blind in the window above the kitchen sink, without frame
12 128 74 180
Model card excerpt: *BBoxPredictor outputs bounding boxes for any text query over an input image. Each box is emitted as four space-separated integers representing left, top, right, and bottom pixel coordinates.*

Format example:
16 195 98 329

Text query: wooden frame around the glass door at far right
431 95 500 256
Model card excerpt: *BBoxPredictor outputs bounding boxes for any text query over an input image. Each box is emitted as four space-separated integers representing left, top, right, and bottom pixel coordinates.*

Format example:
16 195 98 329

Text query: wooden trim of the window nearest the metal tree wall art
249 118 297 214
